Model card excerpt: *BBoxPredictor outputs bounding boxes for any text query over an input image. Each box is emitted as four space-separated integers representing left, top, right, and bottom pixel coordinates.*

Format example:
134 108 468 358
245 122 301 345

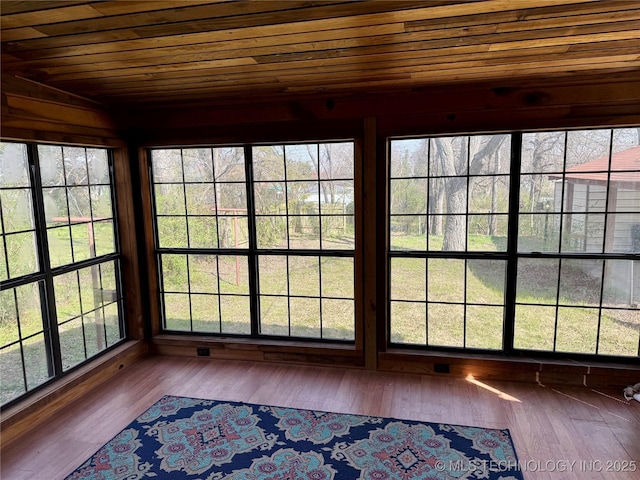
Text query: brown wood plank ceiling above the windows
1 0 640 106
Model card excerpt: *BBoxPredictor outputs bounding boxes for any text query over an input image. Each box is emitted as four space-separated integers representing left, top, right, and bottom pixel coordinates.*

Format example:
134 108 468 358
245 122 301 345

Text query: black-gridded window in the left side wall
0 142 124 404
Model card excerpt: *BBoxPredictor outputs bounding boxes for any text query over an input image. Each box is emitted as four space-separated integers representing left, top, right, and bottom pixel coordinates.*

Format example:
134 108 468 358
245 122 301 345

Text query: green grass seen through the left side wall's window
0 227 121 403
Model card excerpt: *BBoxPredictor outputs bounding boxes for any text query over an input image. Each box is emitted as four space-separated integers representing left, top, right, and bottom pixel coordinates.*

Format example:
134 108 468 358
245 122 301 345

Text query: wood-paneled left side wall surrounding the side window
0 75 148 445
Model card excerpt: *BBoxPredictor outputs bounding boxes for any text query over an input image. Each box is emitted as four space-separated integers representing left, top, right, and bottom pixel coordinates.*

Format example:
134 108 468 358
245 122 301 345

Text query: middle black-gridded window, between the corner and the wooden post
151 142 355 341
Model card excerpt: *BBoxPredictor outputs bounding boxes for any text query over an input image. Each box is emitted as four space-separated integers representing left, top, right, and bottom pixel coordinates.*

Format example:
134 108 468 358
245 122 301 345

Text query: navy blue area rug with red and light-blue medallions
67 396 522 480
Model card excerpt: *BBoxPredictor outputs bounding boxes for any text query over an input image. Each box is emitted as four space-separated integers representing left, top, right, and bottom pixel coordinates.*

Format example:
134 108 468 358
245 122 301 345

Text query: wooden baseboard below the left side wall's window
0 340 147 448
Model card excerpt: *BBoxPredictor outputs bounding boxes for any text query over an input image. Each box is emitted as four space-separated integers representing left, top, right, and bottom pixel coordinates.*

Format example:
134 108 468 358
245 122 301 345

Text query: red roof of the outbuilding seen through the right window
549 145 640 186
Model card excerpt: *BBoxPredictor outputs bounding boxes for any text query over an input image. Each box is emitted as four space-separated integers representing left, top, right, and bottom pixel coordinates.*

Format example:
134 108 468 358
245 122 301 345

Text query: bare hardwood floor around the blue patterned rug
0 357 640 480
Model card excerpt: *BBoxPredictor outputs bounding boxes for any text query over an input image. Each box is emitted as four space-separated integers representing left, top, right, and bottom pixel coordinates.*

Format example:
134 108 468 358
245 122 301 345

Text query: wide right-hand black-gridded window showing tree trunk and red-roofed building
389 129 640 357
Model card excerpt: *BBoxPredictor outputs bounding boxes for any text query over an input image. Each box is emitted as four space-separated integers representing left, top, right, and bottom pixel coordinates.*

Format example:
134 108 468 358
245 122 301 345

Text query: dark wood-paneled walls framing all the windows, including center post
1 71 640 446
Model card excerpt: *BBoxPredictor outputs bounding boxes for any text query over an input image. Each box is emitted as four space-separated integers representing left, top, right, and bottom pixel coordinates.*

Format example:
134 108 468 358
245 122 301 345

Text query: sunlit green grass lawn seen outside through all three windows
0 230 640 401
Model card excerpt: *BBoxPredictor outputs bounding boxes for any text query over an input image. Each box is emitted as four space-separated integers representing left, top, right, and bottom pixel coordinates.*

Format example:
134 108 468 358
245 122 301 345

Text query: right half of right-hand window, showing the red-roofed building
514 129 640 356
